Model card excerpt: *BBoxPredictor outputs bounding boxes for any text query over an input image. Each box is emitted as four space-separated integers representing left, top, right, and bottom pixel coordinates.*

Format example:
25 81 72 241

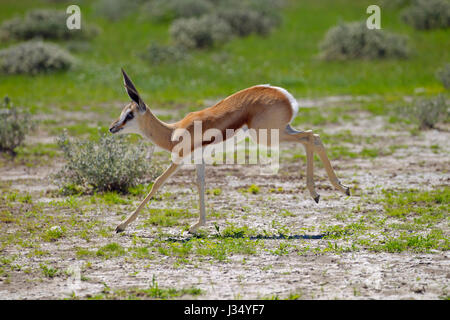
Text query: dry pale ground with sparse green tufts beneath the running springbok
0 99 450 299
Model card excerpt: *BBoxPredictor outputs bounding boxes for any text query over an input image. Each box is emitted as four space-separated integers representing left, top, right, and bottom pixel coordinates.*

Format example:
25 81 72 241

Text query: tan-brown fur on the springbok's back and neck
111 86 293 155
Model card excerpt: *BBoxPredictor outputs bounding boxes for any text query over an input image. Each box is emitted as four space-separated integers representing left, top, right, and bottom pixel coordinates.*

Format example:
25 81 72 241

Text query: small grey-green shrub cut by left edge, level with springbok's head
0 97 34 155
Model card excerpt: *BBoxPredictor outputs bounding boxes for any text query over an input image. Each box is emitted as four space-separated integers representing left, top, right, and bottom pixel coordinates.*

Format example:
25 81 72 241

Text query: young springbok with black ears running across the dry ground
109 69 350 233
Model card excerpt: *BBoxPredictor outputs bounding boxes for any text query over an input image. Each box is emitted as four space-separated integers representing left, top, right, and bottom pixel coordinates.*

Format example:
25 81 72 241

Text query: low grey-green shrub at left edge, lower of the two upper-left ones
0 40 75 74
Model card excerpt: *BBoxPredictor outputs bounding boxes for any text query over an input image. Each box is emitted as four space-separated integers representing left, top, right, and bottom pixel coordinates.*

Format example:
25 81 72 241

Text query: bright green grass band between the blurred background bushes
0 0 450 110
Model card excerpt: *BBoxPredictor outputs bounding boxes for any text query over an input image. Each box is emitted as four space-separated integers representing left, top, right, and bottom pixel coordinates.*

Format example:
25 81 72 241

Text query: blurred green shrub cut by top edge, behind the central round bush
142 0 214 21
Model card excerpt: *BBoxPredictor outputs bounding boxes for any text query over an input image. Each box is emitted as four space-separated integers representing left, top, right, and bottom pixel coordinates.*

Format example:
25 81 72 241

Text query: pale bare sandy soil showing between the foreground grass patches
0 98 450 299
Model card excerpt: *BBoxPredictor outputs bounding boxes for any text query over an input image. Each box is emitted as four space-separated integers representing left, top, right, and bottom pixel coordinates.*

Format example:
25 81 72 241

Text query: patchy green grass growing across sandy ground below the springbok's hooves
0 182 450 299
